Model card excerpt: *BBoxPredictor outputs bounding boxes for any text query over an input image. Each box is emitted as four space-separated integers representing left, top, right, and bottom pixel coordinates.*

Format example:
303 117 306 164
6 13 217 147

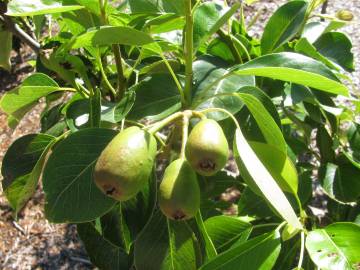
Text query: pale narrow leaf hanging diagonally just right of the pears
233 129 302 229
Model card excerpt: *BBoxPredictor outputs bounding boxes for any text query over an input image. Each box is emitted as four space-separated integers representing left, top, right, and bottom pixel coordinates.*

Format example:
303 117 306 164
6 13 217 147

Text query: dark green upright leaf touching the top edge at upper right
261 1 308 55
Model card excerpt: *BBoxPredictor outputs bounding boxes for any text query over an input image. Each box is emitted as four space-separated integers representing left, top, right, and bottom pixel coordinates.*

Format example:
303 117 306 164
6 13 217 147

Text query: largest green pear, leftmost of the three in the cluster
94 127 157 201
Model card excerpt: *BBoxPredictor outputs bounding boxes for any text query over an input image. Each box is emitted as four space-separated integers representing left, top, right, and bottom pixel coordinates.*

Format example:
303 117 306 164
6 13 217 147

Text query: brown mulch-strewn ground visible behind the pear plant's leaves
0 0 360 270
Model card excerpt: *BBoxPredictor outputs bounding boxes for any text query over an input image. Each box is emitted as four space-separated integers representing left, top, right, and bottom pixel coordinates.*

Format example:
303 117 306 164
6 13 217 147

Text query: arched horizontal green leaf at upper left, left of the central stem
72 26 154 49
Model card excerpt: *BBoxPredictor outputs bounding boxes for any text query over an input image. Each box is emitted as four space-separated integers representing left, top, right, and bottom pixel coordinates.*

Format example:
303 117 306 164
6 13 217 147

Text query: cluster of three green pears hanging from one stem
94 115 229 220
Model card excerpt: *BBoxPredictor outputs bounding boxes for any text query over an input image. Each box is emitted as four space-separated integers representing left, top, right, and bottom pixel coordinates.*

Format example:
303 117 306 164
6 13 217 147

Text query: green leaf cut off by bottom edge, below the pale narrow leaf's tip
200 231 281 270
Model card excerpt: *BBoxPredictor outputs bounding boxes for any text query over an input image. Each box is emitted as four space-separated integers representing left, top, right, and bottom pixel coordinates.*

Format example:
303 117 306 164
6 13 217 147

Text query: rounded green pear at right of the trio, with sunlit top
185 119 229 176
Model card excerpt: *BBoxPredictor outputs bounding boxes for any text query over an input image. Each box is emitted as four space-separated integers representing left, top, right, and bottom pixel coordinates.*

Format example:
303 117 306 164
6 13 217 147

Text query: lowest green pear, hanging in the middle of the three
159 159 200 220
